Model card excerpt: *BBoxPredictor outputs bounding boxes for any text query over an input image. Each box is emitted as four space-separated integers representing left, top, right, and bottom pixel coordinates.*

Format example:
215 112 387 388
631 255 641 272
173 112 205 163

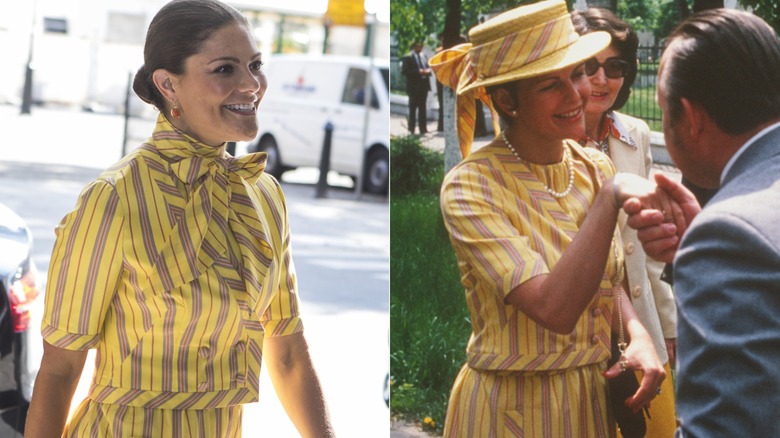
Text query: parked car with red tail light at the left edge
0 204 43 404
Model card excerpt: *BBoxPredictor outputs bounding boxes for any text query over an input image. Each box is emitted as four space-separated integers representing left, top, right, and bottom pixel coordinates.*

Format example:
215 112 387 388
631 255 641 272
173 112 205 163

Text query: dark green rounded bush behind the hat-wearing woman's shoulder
390 135 444 197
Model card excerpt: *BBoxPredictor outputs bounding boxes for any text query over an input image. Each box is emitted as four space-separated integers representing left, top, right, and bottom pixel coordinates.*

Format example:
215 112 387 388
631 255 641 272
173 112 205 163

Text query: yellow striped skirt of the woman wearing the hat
444 362 615 438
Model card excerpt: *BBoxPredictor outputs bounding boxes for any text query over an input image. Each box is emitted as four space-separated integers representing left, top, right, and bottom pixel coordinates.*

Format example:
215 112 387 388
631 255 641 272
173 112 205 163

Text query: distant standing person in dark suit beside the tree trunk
401 41 431 134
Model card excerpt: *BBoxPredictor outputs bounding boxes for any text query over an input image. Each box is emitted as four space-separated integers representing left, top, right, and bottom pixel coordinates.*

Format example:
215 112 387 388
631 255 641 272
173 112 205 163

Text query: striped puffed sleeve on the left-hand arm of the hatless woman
41 180 123 350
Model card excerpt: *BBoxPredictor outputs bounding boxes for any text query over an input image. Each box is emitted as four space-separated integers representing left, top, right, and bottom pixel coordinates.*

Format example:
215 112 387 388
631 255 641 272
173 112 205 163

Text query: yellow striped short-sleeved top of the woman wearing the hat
441 140 623 437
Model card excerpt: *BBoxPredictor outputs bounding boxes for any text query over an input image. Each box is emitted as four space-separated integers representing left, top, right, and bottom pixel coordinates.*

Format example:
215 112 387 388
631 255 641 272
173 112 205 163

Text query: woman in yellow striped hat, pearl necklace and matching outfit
430 0 679 437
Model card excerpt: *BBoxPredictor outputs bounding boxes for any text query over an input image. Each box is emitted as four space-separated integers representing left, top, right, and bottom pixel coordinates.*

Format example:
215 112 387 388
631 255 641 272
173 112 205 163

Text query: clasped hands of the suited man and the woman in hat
612 173 701 263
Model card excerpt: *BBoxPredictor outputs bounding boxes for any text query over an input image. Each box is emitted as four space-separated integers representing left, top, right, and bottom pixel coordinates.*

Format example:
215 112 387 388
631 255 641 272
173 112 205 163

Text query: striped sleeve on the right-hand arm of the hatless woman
260 178 303 336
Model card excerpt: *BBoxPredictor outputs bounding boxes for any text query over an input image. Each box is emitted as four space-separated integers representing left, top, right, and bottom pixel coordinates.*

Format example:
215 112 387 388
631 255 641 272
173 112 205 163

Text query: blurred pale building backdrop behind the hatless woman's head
0 0 390 114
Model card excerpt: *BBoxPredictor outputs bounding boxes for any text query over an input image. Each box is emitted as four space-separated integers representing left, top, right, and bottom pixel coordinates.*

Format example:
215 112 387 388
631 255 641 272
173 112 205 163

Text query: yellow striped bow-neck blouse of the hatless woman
42 115 303 436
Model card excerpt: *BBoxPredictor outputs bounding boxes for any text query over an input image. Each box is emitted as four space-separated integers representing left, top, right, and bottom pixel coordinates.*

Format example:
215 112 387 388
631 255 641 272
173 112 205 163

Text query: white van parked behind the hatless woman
237 55 390 193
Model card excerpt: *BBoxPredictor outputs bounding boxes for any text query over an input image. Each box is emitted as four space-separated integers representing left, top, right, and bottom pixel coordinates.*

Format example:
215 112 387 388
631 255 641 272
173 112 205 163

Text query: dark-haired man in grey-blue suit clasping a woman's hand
624 9 780 438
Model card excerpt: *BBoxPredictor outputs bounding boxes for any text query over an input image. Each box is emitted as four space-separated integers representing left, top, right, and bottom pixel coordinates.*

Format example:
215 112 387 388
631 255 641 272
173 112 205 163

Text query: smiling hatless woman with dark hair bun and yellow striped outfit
25 0 333 437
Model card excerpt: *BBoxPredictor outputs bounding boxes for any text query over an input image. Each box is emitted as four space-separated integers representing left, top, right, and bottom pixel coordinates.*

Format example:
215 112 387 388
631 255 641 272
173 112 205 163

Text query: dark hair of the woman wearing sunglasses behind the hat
571 8 639 111
